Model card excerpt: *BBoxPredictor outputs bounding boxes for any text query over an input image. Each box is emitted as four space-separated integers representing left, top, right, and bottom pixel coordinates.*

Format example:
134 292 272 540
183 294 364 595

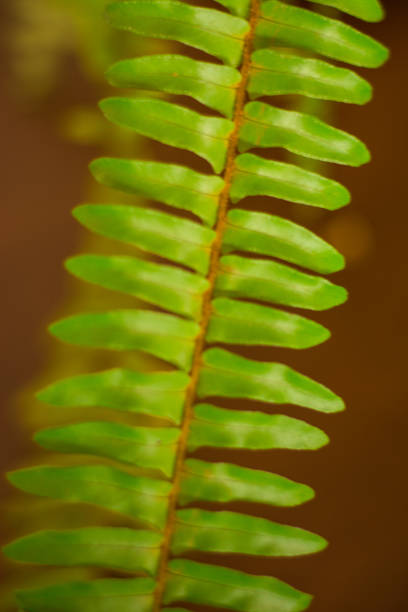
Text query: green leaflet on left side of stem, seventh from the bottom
65 255 208 319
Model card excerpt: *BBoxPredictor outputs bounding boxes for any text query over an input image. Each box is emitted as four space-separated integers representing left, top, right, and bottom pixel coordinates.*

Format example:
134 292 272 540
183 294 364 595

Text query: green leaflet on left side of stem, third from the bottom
8 465 171 529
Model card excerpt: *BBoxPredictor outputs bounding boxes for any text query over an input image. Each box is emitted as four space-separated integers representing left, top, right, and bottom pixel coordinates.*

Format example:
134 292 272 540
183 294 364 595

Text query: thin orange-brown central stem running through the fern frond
153 0 261 612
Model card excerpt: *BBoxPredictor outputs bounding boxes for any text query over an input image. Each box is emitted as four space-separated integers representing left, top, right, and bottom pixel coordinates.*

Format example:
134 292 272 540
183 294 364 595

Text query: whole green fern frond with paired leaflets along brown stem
6 0 387 612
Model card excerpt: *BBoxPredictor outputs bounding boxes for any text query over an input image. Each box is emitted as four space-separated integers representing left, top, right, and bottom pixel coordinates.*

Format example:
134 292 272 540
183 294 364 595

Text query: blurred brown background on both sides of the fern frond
0 0 408 612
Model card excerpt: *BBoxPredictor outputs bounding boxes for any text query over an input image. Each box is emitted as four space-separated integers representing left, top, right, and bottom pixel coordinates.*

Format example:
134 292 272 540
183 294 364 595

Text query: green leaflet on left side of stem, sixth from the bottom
50 310 200 371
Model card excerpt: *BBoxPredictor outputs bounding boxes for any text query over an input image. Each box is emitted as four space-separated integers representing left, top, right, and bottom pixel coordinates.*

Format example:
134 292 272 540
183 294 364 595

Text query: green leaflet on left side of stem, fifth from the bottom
37 368 190 424
